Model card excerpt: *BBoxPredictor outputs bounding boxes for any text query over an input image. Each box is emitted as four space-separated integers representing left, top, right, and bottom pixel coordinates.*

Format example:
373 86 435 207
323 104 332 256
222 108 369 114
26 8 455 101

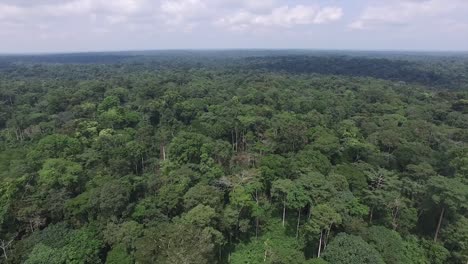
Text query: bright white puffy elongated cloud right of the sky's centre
216 5 343 30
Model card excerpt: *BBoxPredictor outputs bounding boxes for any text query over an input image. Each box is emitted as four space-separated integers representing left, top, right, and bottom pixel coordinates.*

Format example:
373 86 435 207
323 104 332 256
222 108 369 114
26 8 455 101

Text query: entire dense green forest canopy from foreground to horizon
0 50 468 264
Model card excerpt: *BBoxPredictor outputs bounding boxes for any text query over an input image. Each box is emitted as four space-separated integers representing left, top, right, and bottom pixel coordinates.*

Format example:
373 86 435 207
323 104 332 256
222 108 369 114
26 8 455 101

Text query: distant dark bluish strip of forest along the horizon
0 50 468 89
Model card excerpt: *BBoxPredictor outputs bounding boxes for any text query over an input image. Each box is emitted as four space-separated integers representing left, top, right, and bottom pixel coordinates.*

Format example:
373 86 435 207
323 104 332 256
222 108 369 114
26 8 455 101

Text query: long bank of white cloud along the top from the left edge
0 0 343 31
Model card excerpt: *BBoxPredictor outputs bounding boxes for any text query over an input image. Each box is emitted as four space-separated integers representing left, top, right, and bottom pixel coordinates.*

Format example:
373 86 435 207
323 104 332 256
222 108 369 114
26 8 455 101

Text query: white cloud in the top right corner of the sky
349 0 468 29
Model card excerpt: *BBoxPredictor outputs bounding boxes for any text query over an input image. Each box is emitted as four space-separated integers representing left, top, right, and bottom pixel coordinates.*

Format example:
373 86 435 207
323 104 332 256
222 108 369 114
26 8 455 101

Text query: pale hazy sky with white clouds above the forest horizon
0 0 468 53
